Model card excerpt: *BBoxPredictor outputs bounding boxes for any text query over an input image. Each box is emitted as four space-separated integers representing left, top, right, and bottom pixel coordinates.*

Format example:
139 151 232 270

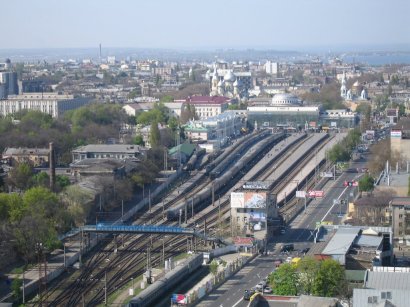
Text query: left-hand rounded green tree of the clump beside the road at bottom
270 263 299 295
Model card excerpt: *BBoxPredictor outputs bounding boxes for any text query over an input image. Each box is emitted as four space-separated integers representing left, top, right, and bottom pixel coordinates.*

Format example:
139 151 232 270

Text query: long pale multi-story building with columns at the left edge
0 93 90 118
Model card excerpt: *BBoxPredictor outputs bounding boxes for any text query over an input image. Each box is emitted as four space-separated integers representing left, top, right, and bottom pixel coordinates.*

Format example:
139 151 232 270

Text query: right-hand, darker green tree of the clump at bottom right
313 259 346 297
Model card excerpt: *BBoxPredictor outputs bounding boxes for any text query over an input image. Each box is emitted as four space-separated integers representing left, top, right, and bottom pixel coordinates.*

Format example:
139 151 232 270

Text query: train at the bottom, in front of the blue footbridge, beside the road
127 253 204 307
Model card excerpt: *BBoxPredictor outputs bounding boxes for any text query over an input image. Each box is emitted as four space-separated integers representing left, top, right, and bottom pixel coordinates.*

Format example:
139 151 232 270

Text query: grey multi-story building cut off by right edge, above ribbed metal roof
390 197 410 245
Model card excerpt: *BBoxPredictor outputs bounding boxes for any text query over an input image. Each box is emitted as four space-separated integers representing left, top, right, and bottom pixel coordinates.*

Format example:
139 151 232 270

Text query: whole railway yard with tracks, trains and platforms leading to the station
27 130 344 306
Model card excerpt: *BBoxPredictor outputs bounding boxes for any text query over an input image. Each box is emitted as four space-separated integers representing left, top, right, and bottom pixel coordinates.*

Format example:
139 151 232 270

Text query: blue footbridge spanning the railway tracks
65 224 228 245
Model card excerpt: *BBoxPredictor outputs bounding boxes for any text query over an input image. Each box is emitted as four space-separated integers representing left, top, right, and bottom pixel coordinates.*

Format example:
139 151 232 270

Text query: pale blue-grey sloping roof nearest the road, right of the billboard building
322 228 360 255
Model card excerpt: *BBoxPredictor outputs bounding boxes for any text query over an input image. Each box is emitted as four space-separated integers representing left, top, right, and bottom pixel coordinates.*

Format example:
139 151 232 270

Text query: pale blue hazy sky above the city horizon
0 0 410 49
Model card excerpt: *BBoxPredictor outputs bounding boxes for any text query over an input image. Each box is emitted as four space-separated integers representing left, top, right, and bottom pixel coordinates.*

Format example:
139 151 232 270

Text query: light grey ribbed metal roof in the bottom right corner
364 271 410 290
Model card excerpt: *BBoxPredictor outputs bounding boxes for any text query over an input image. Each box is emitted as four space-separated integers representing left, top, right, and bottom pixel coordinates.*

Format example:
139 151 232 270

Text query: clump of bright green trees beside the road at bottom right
269 257 348 297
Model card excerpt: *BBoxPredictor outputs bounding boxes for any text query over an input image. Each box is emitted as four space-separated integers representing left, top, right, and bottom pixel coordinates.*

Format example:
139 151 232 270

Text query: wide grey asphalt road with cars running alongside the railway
197 161 365 307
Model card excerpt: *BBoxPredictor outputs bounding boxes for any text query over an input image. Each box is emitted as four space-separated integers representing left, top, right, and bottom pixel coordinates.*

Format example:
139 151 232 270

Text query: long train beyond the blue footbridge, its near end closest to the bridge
167 133 285 221
